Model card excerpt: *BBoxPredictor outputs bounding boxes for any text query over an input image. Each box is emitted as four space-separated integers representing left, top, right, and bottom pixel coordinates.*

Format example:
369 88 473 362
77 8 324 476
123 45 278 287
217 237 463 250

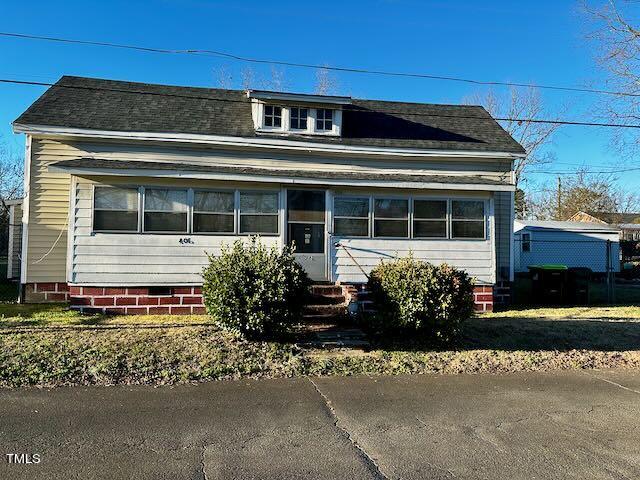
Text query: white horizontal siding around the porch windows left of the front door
71 181 280 286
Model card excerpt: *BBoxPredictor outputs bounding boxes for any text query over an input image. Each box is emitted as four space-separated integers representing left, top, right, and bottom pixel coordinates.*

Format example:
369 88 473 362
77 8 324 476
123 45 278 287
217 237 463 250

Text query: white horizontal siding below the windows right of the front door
331 237 495 284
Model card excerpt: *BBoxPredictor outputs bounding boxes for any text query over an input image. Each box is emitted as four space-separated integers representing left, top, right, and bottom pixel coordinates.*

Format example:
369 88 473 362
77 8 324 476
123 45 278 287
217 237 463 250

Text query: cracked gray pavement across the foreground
0 371 640 479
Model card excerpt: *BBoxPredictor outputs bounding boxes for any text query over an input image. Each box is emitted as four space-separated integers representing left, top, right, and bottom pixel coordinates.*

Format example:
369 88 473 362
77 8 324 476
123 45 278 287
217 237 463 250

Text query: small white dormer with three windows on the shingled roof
247 90 351 136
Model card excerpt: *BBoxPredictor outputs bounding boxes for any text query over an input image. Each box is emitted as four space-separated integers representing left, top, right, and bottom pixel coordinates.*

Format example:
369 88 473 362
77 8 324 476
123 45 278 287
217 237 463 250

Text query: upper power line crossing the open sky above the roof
0 32 640 97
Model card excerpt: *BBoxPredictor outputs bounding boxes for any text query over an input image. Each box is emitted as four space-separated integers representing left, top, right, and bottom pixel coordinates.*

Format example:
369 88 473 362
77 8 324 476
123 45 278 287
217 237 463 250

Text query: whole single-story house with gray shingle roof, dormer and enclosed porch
13 77 524 313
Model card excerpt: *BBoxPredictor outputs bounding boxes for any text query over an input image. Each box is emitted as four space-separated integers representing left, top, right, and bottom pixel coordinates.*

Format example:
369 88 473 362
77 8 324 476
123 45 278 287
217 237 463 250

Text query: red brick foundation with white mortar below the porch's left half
69 285 205 315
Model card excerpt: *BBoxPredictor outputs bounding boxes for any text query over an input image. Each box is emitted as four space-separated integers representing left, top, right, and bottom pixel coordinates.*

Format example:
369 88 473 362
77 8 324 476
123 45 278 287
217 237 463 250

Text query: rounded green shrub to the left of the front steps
202 237 309 338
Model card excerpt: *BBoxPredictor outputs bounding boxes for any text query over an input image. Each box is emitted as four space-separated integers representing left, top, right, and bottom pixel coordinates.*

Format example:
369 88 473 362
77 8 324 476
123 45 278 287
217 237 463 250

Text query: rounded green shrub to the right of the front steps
369 256 473 342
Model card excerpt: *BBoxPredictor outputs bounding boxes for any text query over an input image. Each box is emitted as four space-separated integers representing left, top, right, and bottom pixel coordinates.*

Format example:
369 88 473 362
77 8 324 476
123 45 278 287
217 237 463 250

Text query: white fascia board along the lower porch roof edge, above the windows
49 165 515 192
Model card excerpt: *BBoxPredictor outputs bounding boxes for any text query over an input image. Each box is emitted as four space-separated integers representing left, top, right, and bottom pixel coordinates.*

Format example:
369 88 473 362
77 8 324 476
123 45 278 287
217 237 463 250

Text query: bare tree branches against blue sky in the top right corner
583 0 640 155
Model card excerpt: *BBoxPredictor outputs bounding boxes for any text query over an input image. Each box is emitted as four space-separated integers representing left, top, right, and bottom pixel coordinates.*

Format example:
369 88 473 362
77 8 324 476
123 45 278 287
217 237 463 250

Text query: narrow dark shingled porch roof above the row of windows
50 158 510 186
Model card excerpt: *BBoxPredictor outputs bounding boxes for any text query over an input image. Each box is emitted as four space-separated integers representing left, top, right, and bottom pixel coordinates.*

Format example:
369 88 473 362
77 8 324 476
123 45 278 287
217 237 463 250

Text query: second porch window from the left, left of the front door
144 188 189 233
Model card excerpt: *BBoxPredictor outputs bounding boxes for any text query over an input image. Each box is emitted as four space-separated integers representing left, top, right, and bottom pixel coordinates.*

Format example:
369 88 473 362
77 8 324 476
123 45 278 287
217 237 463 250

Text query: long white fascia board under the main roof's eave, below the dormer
13 123 525 160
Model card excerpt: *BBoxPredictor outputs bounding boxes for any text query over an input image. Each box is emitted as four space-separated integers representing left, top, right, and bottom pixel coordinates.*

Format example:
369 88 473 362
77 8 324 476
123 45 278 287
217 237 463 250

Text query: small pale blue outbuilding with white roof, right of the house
513 220 620 273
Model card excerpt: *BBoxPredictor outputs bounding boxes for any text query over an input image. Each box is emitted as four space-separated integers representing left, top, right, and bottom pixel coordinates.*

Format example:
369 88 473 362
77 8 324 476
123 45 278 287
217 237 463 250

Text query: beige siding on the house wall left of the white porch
22 139 77 283
